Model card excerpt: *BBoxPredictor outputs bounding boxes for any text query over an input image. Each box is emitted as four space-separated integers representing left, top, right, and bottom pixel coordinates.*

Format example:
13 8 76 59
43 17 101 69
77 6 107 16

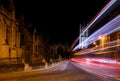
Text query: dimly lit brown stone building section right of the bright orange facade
18 16 44 69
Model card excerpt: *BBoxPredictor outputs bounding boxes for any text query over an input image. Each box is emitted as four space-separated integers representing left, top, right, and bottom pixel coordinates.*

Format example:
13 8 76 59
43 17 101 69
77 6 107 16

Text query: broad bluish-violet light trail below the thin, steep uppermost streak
73 15 120 51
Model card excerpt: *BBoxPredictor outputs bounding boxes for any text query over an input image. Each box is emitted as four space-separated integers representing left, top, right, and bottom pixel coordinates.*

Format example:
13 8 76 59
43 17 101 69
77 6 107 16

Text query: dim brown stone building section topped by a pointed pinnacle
31 28 44 63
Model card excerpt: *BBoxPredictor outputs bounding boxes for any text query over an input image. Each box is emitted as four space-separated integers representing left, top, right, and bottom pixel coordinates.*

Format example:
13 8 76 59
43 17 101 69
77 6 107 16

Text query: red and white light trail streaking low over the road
71 58 120 71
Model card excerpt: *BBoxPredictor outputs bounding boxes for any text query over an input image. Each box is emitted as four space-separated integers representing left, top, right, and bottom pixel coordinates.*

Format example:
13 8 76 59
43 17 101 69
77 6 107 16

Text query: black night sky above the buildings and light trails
14 0 109 44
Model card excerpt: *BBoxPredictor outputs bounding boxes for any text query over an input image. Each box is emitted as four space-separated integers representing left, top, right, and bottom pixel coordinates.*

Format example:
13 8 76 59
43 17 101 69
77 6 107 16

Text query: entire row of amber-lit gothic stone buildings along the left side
0 0 49 72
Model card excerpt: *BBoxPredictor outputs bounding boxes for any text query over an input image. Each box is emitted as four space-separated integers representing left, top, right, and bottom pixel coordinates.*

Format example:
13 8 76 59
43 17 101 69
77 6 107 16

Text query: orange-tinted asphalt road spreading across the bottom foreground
0 61 119 81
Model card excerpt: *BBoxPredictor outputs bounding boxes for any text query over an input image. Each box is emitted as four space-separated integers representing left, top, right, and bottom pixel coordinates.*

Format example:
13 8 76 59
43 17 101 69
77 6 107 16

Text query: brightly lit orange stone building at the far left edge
0 0 23 71
